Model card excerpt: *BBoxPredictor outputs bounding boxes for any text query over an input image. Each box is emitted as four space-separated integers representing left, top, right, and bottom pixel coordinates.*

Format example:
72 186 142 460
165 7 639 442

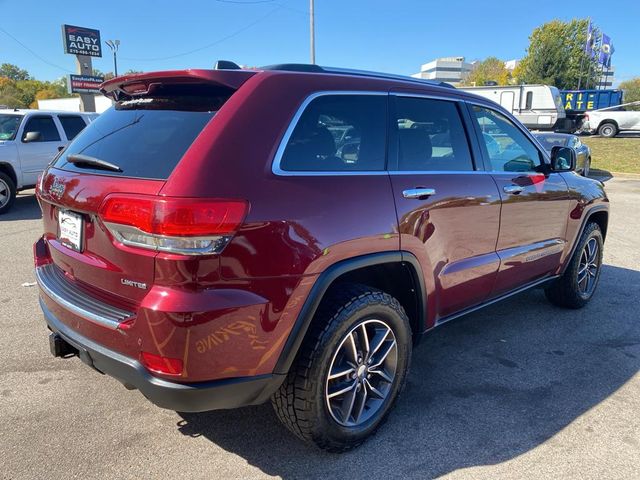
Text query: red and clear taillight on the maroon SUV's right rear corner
99 194 249 255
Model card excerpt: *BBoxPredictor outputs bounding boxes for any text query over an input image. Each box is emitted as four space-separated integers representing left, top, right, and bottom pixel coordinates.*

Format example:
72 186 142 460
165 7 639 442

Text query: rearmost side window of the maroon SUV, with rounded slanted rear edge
280 95 387 172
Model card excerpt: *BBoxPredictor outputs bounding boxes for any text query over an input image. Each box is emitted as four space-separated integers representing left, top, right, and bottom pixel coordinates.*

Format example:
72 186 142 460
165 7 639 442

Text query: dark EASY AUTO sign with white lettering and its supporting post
62 25 102 112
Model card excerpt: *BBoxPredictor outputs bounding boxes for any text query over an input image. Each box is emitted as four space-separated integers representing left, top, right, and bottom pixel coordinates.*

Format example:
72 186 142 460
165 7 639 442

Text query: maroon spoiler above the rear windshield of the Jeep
100 70 257 101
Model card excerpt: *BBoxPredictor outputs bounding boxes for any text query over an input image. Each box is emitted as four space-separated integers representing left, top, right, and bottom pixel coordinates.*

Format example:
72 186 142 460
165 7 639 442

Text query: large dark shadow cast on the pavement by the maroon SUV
178 266 640 478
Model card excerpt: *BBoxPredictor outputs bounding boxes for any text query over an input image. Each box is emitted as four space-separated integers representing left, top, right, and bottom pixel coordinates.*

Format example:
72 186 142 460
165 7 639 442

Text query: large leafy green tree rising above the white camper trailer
519 19 597 89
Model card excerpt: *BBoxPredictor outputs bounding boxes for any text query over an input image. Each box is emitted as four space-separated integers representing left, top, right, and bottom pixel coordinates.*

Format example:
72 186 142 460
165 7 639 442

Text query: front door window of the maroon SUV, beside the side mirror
472 106 540 172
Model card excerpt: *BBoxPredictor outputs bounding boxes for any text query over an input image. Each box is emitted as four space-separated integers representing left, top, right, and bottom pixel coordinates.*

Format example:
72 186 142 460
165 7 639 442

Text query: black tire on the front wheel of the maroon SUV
544 222 603 308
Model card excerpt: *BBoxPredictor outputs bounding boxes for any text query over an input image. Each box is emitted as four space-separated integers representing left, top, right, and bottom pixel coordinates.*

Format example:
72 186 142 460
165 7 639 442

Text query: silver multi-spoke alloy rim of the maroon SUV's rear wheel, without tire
325 320 398 427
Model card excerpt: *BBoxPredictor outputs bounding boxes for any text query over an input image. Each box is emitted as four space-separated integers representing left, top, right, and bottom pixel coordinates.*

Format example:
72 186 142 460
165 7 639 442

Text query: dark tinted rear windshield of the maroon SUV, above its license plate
54 93 230 180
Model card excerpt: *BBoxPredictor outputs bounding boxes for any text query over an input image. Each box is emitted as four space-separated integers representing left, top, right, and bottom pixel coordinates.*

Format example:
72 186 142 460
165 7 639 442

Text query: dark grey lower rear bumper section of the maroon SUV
40 299 284 412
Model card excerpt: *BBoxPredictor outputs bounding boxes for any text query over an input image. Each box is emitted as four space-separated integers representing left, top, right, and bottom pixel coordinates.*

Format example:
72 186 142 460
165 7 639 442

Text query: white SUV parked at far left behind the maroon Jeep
0 109 96 214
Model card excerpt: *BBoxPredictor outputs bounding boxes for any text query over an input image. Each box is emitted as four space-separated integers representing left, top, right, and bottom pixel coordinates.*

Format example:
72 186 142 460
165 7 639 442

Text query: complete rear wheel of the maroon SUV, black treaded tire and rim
272 285 411 452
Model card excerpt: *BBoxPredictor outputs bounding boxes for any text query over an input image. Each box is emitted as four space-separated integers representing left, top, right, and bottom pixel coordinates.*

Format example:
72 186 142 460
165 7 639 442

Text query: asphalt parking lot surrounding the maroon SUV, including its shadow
0 177 640 479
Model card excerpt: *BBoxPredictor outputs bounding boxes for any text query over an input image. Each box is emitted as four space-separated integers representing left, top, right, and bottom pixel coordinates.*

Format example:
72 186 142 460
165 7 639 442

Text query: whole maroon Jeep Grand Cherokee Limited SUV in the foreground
34 62 609 451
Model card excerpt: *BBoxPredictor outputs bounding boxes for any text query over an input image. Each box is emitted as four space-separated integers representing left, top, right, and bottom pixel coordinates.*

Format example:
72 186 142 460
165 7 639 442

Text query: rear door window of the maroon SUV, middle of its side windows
396 97 473 171
